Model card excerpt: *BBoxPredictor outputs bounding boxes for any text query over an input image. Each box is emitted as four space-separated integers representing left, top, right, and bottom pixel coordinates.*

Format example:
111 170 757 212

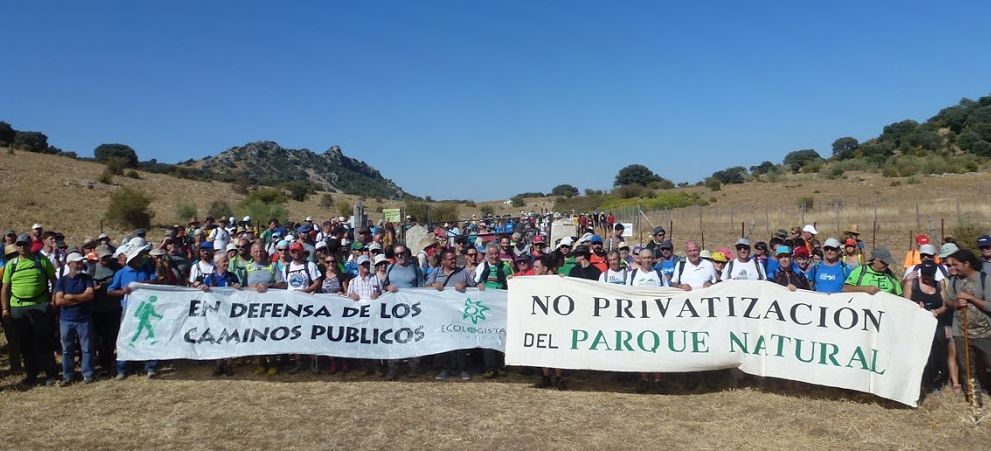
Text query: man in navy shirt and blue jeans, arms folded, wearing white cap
55 252 94 385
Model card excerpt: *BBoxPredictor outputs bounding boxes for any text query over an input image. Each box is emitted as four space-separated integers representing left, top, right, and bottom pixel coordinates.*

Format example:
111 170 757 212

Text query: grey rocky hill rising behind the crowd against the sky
177 141 407 199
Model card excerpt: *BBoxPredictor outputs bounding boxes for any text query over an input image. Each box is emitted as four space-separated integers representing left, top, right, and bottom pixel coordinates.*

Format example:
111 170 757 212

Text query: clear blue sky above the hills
0 0 991 200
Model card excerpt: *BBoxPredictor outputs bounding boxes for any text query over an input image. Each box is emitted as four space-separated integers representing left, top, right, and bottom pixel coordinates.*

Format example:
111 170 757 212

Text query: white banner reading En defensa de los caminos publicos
117 284 506 360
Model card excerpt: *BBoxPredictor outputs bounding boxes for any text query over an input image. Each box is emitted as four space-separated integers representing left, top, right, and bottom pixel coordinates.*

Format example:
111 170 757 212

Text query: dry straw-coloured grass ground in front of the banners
0 354 991 450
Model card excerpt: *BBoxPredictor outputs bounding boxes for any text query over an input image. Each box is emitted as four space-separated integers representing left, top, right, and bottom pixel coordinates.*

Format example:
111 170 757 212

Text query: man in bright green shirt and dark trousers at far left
0 234 58 386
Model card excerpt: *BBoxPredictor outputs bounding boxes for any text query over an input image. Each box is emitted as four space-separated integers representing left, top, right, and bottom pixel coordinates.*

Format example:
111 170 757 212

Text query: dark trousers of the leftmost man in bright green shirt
10 302 58 380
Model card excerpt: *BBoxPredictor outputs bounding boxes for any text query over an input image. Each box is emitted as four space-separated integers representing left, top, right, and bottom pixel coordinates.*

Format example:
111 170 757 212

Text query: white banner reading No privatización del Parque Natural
506 276 936 406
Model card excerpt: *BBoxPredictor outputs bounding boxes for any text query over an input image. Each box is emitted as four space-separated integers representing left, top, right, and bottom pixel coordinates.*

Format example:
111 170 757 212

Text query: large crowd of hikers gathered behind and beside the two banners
0 212 991 404
